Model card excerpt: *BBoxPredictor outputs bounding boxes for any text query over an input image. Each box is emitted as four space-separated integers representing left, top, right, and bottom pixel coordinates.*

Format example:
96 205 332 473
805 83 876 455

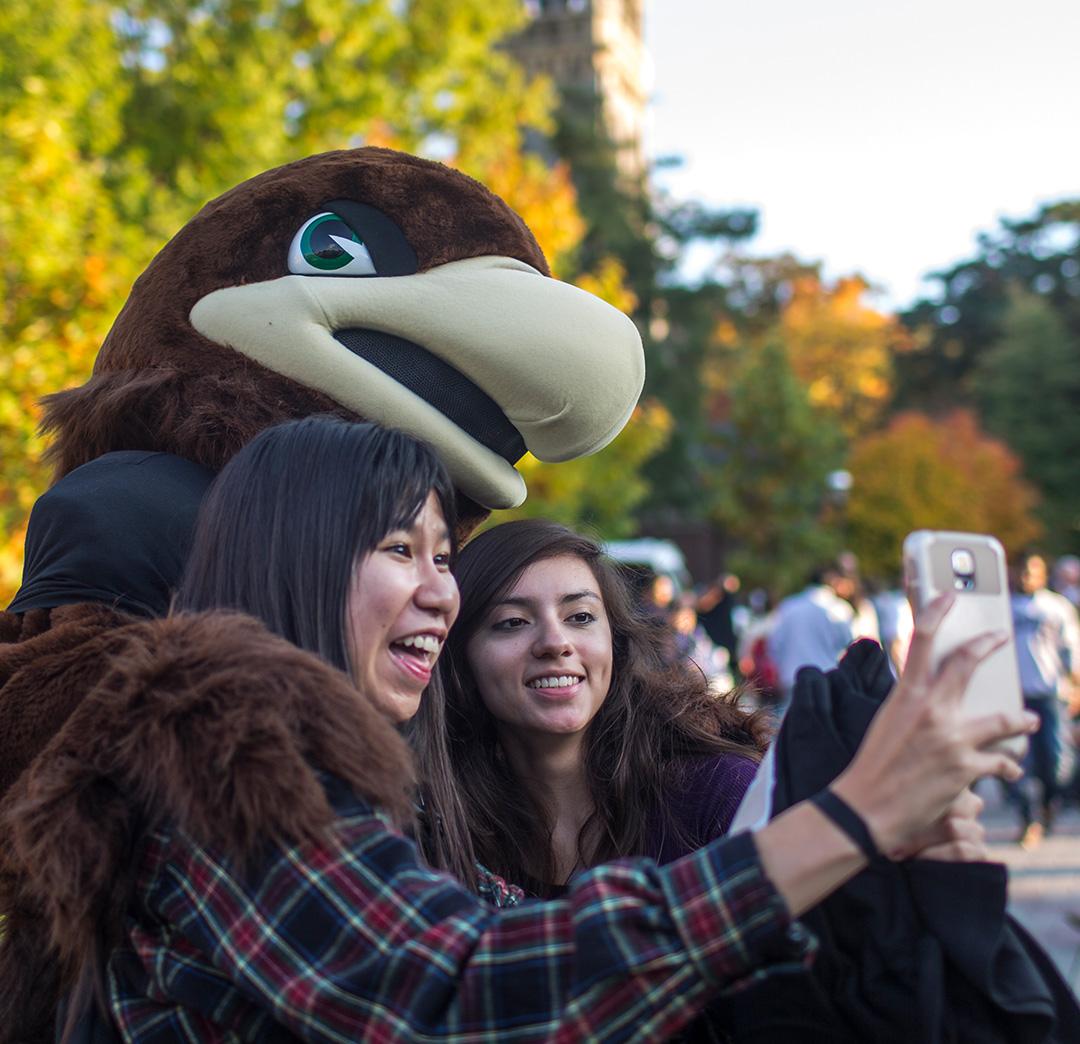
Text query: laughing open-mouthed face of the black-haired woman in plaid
346 493 459 721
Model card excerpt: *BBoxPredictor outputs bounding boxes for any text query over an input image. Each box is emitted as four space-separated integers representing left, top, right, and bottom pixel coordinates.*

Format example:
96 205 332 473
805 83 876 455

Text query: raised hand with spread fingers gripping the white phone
832 595 1038 854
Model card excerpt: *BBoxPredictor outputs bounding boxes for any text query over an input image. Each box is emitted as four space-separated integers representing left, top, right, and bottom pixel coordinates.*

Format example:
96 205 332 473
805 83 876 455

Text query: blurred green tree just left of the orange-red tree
702 340 843 592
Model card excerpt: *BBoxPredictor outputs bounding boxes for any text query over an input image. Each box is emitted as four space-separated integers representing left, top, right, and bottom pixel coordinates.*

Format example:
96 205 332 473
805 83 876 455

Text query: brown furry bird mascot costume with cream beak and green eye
0 148 644 1041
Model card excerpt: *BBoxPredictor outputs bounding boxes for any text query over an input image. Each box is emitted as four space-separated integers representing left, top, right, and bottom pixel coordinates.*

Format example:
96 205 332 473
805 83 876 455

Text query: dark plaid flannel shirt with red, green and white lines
107 781 813 1044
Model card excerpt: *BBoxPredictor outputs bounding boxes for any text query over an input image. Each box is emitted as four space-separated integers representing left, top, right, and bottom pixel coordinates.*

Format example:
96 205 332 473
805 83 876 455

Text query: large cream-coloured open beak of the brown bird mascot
190 257 645 507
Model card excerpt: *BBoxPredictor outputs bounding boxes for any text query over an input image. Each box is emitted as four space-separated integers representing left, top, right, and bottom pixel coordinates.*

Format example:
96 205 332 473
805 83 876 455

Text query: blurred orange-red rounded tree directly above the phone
847 410 1040 580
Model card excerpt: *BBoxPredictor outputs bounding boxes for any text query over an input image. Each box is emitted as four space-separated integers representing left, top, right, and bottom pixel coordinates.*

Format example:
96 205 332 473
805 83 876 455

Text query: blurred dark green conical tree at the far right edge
973 289 1080 553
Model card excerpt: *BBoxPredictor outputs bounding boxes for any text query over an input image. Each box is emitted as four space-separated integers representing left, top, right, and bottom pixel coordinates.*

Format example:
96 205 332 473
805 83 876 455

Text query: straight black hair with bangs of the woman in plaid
175 417 474 884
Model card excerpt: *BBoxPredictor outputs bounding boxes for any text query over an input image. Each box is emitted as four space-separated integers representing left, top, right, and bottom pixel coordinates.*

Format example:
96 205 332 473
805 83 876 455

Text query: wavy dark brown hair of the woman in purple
421 519 768 895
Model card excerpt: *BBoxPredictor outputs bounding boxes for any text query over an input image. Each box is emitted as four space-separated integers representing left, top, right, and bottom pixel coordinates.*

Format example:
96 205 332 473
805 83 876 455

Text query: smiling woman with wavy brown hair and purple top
425 519 767 896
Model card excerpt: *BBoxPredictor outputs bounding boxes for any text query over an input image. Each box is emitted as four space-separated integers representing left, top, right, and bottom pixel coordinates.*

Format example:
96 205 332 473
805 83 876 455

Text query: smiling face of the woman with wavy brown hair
465 555 611 737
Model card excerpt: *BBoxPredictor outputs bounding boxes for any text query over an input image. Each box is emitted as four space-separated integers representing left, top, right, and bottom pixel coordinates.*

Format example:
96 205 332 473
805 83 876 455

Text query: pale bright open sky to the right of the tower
646 0 1080 307
